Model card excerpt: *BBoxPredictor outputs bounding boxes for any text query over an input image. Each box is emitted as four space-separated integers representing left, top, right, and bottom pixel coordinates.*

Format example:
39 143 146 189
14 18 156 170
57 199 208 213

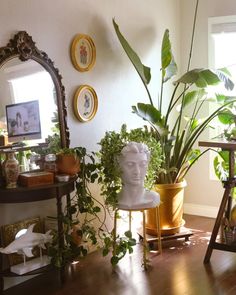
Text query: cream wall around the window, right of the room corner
180 0 236 216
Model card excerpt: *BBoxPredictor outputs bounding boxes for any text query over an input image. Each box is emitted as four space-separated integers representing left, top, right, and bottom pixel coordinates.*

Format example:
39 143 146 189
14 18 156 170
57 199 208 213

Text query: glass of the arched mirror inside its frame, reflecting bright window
0 58 59 145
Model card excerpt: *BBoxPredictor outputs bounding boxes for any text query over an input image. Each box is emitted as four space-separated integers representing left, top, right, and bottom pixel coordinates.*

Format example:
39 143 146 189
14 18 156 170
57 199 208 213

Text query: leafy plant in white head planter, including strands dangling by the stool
97 124 162 266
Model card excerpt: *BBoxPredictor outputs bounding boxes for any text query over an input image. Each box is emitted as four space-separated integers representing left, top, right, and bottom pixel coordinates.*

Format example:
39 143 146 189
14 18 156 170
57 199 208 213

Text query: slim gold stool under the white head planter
113 205 162 269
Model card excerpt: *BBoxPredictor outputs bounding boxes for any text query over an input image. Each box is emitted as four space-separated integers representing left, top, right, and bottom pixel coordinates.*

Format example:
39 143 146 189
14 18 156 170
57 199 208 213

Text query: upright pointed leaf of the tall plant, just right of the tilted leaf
161 30 177 82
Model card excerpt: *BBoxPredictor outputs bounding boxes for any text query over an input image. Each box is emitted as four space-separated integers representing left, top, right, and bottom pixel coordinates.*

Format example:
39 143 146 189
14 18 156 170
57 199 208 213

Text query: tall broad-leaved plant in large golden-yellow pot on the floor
113 1 233 234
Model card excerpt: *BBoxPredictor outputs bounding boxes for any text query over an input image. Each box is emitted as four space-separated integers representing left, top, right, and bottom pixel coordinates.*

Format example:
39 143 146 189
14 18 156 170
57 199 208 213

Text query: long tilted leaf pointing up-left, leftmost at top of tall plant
113 19 151 85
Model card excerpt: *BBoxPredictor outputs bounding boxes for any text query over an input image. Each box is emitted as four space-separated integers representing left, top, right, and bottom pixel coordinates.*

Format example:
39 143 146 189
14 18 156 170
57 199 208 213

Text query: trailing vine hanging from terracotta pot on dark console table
48 147 105 267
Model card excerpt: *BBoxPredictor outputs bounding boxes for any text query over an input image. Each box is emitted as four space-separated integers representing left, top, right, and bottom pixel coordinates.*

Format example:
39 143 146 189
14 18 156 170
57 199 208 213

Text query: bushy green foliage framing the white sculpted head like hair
98 124 162 208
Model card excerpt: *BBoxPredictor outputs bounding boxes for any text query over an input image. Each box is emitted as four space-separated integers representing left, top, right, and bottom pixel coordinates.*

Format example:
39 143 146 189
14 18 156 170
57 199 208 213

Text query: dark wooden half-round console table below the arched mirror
0 178 76 293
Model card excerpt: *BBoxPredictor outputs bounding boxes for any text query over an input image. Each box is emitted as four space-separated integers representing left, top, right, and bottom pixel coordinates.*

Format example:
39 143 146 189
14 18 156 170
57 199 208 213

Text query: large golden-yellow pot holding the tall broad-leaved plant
146 181 187 236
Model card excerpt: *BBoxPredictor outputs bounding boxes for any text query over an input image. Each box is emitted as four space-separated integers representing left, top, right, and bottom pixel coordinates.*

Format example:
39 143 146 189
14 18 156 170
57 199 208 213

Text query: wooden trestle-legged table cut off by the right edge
199 141 236 263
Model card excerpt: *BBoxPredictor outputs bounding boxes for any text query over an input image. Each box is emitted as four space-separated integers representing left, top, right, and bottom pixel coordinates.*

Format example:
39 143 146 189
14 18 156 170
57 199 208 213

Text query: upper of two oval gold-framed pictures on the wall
71 34 96 72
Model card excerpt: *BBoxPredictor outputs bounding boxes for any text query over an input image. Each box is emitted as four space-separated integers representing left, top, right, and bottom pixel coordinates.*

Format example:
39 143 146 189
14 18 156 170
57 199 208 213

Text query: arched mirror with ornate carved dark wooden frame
0 31 70 148
